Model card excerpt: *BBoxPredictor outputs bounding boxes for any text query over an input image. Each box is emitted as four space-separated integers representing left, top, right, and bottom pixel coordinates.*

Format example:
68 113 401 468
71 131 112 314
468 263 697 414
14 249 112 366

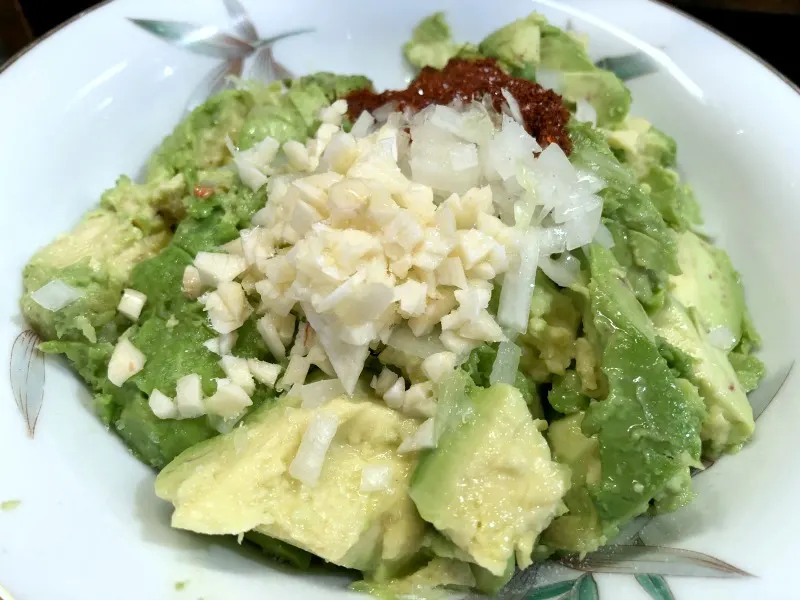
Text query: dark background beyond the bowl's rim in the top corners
0 0 800 83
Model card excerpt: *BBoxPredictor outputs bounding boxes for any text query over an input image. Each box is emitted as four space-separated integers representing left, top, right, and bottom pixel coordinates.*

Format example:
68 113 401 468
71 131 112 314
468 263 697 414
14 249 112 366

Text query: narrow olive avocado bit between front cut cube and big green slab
541 412 607 553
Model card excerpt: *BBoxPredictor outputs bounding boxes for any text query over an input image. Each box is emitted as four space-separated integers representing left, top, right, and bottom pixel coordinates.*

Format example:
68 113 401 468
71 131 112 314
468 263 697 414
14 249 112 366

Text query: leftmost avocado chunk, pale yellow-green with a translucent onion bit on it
21 209 169 341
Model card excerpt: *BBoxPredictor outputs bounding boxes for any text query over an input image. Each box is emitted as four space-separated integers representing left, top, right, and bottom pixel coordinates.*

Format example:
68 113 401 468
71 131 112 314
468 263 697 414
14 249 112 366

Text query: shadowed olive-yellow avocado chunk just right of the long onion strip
518 272 581 383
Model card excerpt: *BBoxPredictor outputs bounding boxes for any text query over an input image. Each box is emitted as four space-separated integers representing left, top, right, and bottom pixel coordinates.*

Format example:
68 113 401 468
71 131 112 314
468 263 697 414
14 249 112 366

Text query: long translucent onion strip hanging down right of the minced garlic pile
497 230 539 333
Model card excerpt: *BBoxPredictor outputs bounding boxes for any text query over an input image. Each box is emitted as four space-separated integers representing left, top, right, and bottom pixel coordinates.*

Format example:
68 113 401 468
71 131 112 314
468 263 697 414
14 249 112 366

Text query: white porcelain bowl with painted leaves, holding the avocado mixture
0 0 800 600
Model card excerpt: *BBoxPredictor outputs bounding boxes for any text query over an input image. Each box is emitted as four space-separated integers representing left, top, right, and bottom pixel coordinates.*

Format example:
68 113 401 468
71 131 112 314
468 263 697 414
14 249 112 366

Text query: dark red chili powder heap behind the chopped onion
347 58 572 154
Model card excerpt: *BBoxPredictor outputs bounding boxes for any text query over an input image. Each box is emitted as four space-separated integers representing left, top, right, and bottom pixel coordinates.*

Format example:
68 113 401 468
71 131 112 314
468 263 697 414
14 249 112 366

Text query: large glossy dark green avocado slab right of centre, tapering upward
582 245 705 523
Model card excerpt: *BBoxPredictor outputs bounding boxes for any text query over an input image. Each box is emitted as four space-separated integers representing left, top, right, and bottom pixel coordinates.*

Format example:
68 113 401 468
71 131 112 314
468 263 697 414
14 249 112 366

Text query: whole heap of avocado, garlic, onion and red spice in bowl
22 14 764 595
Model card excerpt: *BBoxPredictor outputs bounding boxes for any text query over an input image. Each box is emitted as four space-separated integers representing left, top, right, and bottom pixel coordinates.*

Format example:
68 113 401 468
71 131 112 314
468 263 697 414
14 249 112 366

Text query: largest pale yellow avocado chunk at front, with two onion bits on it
156 396 432 570
